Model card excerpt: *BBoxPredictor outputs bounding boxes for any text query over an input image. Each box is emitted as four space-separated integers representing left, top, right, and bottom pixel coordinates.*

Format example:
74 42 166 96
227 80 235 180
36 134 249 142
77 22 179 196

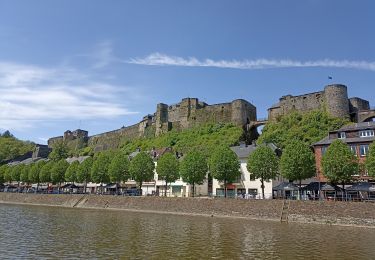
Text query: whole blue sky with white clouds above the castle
0 0 375 144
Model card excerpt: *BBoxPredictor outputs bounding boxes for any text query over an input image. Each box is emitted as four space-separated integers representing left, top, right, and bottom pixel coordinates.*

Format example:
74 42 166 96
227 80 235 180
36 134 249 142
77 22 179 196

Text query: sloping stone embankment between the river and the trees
0 192 375 228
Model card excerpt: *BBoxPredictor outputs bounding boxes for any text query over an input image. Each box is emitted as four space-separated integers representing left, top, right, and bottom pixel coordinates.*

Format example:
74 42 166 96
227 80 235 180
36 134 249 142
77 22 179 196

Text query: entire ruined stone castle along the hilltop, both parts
48 84 375 152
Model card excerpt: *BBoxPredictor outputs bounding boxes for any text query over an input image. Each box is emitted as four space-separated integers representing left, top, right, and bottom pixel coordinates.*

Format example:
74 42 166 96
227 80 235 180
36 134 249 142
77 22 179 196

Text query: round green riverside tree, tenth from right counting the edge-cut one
91 152 111 193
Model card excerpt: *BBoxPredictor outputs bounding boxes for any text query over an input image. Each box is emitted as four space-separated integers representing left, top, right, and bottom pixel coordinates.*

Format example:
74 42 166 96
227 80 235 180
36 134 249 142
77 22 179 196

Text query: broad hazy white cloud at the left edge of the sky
0 62 135 130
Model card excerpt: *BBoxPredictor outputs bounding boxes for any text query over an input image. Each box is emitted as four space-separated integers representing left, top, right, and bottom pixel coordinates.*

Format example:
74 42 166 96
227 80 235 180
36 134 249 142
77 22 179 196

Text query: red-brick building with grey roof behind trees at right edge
313 122 375 182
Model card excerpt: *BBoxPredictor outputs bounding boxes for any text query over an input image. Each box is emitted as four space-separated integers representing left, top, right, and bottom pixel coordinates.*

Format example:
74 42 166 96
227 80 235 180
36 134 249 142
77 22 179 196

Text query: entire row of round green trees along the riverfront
0 140 375 197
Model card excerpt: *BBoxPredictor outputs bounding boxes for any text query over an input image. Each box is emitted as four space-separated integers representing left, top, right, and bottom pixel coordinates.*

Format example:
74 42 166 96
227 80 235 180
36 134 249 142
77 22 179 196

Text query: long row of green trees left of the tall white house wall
0 146 244 195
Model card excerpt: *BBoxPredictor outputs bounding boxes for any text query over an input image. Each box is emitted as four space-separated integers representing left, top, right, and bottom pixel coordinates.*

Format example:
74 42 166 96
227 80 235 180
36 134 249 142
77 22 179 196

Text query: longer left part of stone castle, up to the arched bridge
48 98 258 152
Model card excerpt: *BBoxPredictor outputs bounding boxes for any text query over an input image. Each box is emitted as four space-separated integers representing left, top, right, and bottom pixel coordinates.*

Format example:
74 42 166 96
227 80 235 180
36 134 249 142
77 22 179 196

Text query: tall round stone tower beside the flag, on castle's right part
324 84 350 119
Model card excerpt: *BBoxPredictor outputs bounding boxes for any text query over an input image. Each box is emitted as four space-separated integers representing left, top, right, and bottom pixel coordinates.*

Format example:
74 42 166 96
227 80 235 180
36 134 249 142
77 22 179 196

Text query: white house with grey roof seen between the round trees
212 143 283 199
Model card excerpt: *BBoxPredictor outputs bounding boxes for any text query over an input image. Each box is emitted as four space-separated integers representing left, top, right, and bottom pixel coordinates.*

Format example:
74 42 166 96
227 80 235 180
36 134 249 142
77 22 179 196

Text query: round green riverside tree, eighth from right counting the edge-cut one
129 152 155 193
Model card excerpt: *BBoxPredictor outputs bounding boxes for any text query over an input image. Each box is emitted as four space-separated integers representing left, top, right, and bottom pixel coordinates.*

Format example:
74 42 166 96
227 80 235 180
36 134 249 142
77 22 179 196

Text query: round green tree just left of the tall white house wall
209 146 241 198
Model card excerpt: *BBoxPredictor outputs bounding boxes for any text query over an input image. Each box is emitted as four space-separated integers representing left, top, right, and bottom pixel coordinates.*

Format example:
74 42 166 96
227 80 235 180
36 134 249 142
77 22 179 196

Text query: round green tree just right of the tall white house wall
247 145 279 199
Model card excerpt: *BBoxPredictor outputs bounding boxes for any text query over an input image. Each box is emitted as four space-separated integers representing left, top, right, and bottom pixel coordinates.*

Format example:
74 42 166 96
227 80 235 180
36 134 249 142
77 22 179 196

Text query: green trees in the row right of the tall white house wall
247 140 375 197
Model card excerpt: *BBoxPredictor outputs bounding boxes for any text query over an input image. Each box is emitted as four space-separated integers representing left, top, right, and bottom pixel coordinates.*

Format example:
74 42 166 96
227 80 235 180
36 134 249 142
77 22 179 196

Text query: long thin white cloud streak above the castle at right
128 53 375 71
